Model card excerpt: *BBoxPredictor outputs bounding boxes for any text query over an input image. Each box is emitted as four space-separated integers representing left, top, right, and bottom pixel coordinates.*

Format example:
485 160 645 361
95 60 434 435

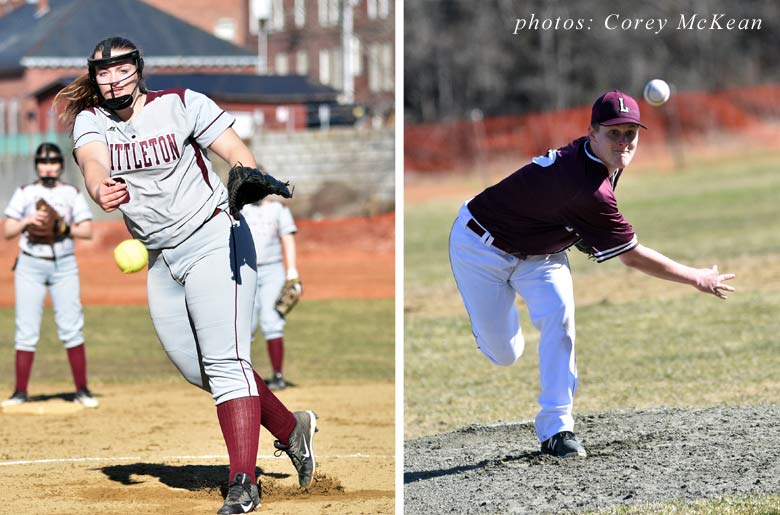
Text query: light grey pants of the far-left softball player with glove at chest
14 254 84 352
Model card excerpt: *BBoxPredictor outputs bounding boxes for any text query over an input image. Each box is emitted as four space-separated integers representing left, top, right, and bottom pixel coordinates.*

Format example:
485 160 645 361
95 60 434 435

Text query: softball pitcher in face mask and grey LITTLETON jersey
56 37 316 514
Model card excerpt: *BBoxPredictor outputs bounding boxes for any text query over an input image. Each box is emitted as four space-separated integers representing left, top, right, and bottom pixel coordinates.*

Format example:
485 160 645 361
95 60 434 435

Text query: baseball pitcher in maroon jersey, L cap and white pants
450 91 734 457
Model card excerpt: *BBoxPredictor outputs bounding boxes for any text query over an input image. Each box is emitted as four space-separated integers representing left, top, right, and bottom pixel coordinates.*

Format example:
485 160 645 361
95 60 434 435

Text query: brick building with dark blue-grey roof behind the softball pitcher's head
0 0 257 137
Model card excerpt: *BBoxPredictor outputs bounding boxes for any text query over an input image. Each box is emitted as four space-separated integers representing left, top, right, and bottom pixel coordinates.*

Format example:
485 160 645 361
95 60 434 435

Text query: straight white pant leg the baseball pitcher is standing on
512 252 577 441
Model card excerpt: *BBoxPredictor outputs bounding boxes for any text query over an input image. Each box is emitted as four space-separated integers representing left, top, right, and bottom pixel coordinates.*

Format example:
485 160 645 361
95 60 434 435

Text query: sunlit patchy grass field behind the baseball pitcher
404 155 780 514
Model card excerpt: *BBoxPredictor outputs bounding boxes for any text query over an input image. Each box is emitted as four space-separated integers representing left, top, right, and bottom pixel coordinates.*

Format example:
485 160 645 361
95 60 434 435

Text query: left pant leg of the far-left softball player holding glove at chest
14 254 48 352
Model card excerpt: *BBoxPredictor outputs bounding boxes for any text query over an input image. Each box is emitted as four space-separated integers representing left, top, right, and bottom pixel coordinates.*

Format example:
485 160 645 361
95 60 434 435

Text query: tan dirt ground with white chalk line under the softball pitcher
0 378 395 515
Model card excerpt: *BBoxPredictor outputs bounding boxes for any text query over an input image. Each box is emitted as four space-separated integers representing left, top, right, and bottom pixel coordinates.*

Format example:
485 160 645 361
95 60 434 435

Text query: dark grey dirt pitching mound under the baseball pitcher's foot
404 406 780 514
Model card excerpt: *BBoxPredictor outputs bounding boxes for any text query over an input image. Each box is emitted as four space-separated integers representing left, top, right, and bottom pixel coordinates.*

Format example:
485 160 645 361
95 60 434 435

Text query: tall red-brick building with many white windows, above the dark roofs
141 0 395 115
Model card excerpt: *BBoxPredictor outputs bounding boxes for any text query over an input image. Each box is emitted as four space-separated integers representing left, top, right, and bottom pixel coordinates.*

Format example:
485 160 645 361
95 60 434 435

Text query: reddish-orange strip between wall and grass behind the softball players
0 214 395 306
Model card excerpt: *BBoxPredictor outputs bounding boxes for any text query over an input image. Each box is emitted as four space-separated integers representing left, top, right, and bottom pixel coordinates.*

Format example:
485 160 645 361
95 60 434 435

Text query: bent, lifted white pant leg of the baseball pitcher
450 214 525 366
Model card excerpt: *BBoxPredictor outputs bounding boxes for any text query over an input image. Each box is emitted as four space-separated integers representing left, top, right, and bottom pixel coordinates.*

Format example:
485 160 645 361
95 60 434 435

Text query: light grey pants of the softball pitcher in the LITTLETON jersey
147 212 258 404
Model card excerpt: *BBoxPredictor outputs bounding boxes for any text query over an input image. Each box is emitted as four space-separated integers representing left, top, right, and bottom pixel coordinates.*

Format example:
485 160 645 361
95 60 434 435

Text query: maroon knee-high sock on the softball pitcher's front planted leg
217 397 260 483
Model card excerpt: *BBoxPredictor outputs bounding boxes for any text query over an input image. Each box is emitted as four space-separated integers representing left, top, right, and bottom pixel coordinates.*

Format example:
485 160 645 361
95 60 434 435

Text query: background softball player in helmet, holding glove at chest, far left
2 143 98 408
